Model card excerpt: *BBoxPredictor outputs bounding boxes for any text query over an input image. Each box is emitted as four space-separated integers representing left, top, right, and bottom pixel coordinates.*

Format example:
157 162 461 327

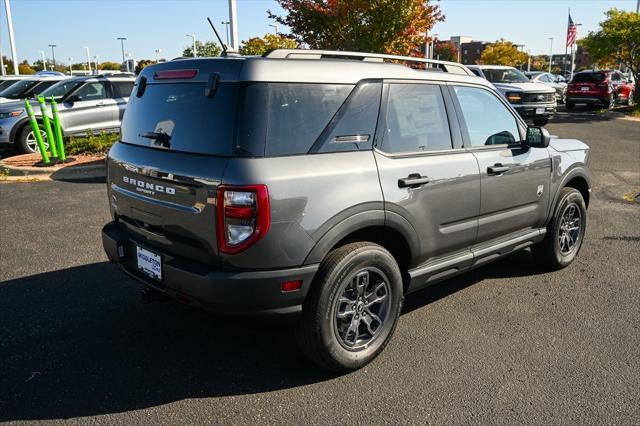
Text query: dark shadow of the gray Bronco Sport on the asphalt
0 253 535 421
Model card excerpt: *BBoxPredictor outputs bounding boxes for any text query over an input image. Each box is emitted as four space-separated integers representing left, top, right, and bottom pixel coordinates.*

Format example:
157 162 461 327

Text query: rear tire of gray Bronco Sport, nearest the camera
296 242 404 373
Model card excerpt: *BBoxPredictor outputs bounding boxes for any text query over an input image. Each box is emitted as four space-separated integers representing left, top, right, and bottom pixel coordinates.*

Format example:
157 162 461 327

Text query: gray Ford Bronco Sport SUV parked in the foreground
102 50 591 371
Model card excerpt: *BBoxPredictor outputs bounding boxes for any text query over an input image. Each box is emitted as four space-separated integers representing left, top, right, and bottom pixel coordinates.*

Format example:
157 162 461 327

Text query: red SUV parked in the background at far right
567 70 635 109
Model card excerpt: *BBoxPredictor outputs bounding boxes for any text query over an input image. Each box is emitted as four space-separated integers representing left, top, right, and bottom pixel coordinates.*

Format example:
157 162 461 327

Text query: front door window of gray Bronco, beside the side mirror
454 86 520 147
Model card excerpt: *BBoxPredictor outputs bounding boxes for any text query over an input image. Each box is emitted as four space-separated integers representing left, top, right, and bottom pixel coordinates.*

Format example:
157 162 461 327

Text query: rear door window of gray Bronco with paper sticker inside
382 84 451 154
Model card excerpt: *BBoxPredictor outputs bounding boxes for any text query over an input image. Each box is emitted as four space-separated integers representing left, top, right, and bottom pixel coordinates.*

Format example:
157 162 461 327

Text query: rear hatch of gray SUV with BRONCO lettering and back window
108 58 243 264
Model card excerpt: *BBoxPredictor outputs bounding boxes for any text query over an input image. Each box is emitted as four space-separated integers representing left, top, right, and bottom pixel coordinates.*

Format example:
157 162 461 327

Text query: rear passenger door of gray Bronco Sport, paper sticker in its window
375 81 480 265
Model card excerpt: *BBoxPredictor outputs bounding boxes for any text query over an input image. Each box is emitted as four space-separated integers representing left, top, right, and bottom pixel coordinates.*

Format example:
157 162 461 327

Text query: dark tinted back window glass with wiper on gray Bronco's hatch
121 83 239 156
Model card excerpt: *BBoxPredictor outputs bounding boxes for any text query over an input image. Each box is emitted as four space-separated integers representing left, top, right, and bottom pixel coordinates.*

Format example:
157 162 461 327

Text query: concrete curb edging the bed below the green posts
0 161 107 181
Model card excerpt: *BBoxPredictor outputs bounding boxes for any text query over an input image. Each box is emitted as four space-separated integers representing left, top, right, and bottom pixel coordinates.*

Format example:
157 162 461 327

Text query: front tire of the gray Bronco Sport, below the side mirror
532 188 587 270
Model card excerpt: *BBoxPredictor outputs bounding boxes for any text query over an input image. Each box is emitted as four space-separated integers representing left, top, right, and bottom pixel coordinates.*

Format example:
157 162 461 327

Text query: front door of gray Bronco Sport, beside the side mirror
451 85 551 243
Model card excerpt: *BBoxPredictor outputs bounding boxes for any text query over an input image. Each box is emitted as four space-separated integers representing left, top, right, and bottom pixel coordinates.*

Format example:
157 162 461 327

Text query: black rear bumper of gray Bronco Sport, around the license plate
102 222 318 315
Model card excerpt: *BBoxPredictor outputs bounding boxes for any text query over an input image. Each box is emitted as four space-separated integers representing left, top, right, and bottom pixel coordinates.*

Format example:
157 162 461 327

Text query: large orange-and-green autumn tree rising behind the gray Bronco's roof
268 0 444 56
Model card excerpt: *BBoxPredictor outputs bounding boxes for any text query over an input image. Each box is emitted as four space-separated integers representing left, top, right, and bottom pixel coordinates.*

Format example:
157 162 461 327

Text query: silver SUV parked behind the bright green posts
0 74 135 153
